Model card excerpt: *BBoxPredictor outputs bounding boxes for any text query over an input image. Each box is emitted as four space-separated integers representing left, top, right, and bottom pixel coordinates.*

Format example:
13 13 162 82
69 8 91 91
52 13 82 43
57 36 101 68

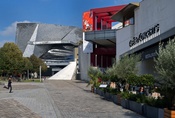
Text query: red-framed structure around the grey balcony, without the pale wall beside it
83 5 125 68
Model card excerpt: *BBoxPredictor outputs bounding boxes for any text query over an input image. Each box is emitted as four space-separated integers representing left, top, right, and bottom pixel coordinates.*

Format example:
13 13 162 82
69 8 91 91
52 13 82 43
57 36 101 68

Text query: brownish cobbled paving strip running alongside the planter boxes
45 80 143 118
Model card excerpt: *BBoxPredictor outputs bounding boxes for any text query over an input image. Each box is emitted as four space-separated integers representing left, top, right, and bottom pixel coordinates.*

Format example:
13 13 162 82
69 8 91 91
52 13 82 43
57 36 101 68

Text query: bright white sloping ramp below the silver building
48 62 76 80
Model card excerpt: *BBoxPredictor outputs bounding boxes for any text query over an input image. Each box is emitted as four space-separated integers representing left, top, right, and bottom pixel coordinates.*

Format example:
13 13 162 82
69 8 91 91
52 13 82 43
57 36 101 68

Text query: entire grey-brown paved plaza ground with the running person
0 80 145 118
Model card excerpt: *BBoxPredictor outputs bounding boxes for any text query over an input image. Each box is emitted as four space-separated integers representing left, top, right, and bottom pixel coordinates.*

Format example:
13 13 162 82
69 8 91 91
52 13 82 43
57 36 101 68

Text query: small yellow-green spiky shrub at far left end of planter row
87 67 102 87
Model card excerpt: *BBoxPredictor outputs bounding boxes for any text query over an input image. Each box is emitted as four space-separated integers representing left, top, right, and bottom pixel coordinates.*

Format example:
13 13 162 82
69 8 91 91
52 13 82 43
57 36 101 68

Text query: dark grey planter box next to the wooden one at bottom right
143 105 164 118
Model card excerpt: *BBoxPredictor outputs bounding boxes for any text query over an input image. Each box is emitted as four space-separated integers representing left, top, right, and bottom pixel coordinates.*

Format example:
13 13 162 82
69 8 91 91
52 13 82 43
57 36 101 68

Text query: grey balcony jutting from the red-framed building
85 29 116 46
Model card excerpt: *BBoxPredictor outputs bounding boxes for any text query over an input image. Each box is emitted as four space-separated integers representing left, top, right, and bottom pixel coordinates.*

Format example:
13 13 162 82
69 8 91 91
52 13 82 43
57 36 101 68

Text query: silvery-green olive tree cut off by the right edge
154 38 175 107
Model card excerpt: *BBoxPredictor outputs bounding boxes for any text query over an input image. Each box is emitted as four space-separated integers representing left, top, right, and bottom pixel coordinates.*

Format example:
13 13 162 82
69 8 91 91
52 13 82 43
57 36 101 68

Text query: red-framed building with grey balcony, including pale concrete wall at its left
79 5 126 81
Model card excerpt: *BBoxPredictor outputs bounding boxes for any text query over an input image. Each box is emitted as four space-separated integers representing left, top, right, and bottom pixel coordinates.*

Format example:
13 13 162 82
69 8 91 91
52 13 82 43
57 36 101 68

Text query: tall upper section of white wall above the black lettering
135 0 175 36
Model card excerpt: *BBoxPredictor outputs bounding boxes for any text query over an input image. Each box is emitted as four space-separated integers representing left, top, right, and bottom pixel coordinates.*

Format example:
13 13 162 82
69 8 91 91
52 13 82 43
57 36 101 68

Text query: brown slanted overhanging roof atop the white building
111 3 139 22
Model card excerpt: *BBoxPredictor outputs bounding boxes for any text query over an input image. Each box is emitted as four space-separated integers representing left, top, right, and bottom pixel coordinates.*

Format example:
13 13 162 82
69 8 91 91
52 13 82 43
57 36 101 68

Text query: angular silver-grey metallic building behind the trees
16 23 82 75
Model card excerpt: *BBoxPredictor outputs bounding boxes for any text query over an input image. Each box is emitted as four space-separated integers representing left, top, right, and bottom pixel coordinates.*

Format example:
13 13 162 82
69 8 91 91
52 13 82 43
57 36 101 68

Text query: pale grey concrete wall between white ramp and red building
78 45 90 81
